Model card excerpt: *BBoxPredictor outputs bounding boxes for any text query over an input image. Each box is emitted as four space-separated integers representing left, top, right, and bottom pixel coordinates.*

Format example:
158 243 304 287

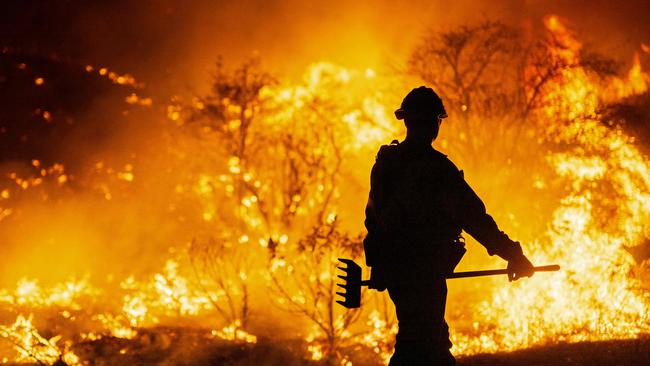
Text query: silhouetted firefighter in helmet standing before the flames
363 86 533 366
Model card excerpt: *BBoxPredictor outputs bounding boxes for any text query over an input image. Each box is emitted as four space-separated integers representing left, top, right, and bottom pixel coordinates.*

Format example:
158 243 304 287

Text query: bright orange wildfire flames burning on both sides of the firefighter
0 12 650 366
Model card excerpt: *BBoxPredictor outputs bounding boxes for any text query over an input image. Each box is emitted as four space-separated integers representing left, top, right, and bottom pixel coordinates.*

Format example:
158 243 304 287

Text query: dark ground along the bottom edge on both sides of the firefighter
63 328 650 366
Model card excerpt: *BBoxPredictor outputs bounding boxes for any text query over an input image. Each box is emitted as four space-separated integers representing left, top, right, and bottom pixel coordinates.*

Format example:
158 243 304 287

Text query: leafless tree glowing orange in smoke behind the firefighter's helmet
408 18 613 166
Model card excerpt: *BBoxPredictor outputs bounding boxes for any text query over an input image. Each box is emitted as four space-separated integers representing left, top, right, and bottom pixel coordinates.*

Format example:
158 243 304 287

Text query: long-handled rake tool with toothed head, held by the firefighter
336 258 560 309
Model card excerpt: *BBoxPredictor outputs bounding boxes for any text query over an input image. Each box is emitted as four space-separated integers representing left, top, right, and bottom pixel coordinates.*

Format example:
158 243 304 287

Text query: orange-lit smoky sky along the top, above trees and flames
2 0 650 92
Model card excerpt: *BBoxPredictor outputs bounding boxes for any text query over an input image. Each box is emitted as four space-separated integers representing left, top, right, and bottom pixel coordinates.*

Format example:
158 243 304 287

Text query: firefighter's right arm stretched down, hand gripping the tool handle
453 169 534 281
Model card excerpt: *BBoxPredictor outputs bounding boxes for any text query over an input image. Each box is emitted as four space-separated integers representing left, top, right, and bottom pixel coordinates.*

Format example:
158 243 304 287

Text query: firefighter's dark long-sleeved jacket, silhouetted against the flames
363 141 521 282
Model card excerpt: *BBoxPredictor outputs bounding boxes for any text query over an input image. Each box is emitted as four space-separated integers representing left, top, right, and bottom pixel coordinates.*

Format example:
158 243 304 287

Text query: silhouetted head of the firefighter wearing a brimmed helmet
395 86 447 141
